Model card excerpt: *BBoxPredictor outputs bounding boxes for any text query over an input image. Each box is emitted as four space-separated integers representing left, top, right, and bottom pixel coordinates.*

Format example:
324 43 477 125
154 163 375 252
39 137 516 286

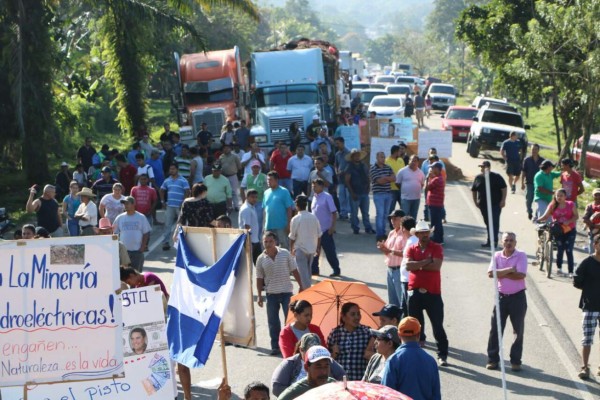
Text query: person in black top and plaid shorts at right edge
573 235 600 379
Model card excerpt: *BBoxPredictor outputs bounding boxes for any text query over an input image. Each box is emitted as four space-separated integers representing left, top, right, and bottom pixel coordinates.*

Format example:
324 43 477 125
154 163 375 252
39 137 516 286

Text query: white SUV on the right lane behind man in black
467 104 529 158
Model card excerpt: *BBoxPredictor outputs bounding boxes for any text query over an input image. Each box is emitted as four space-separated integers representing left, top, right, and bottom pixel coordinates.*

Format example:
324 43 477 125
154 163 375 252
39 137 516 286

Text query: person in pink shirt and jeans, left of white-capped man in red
377 210 409 308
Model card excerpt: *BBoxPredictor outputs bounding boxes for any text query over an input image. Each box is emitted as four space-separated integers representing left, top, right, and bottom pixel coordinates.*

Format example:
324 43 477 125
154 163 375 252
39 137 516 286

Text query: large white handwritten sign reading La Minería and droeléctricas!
0 236 123 386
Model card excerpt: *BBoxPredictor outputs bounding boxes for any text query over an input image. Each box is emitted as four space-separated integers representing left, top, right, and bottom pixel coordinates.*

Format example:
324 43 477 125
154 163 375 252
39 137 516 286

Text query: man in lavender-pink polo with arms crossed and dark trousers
485 232 527 371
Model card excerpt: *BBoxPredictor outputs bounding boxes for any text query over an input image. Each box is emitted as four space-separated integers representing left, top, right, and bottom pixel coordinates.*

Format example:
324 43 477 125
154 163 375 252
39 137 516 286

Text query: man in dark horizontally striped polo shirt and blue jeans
369 151 396 241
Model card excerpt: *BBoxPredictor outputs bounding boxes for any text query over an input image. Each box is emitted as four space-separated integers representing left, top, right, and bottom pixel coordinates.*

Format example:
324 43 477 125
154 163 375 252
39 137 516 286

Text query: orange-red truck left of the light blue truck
173 46 248 143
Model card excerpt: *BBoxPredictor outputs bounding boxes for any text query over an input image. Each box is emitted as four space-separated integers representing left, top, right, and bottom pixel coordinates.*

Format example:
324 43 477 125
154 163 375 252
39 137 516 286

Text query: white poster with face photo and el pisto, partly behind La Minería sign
1 286 175 400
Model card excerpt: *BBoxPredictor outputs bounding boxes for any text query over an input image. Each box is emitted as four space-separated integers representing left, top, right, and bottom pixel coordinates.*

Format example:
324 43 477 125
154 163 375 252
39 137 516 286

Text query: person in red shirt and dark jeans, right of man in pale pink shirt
425 161 446 245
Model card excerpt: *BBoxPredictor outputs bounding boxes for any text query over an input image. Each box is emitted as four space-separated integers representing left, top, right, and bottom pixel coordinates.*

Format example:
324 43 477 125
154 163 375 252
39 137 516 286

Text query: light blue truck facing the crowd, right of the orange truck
248 41 339 148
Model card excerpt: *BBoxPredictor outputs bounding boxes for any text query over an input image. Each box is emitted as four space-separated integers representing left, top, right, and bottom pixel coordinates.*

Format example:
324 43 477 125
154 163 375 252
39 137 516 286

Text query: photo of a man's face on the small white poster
123 321 168 357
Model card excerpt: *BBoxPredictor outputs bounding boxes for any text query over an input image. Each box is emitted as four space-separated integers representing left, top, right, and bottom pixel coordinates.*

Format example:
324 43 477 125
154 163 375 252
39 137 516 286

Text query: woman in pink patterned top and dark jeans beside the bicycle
537 189 579 278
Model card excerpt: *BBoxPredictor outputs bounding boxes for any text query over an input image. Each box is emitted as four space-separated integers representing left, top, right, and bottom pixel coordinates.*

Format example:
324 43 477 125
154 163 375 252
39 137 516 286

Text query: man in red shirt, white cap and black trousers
406 221 448 367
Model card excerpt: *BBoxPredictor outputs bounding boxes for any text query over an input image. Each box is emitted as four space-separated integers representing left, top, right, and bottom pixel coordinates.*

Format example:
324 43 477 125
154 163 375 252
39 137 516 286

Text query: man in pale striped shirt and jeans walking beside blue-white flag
256 231 304 356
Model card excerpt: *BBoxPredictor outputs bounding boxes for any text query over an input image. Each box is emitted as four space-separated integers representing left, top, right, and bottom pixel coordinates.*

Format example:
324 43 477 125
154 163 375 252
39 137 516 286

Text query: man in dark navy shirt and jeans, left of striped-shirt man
344 149 375 235
